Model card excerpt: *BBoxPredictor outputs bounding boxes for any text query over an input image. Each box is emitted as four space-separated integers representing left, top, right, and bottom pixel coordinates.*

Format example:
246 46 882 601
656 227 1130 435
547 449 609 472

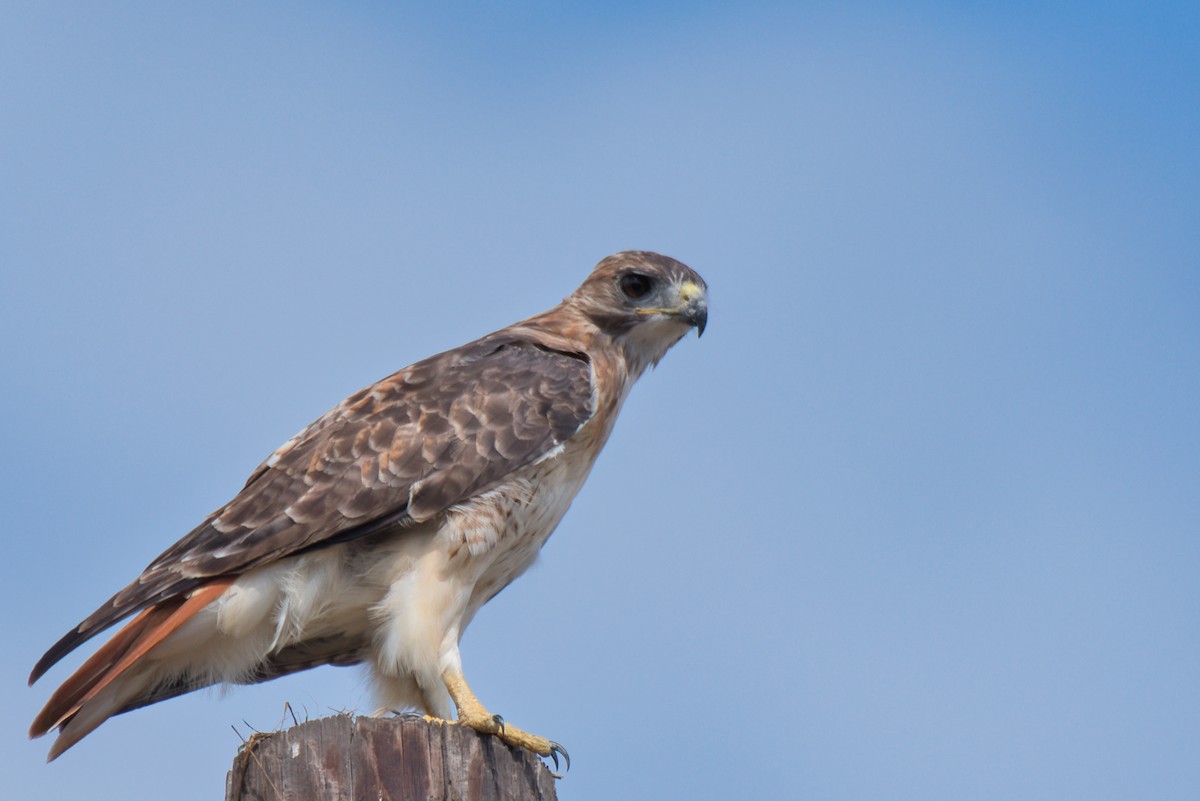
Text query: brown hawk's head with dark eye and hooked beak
568 251 708 372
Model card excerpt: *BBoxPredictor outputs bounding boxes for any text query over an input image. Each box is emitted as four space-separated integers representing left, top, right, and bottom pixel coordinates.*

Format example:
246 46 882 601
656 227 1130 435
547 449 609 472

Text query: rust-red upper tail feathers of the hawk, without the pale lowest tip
29 578 234 740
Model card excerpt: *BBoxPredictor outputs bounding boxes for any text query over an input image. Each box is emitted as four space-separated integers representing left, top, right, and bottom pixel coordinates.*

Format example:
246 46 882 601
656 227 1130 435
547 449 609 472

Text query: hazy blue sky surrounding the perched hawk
0 2 1200 801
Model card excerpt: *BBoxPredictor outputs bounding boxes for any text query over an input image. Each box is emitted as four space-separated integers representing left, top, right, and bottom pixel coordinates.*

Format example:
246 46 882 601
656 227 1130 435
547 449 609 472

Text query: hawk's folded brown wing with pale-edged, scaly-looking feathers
30 335 593 681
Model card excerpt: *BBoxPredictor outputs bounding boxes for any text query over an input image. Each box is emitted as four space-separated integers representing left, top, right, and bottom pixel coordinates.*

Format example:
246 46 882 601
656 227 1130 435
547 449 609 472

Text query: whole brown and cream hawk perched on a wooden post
30 251 708 763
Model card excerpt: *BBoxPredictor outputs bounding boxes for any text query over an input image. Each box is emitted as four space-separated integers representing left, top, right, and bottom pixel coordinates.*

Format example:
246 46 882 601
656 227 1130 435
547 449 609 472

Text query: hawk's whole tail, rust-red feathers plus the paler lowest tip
29 578 234 759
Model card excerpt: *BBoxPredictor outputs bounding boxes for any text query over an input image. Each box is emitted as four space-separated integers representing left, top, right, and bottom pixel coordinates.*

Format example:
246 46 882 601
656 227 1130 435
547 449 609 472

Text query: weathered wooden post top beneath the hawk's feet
226 715 557 801
